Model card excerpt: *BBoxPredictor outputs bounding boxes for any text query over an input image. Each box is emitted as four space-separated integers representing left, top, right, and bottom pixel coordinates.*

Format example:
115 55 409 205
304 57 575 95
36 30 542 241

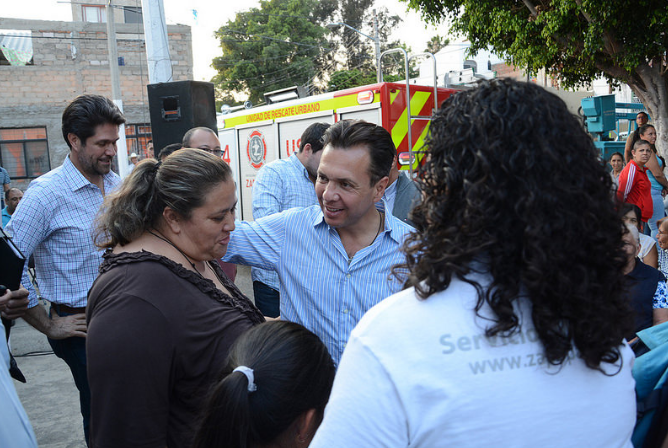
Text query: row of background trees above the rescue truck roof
212 0 426 104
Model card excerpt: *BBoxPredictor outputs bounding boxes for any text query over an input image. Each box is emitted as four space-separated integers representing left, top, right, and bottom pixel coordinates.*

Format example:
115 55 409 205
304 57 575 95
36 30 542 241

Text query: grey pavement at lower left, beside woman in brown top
11 266 253 448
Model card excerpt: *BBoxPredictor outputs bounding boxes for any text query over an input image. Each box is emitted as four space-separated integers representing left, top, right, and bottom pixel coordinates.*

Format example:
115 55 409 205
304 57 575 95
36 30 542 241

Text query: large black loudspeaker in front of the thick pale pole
148 81 218 157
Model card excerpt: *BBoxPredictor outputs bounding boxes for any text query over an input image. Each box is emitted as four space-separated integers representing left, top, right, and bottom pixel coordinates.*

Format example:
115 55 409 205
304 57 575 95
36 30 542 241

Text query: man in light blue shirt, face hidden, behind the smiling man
251 123 330 317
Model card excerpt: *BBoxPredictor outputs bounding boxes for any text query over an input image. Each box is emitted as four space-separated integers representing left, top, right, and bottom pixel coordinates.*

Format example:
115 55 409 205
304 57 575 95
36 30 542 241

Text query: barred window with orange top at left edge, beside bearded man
0 127 51 179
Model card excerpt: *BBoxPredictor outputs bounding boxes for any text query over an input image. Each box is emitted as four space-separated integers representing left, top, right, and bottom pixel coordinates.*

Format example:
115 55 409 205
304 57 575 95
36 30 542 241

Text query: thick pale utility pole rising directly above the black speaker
141 0 173 84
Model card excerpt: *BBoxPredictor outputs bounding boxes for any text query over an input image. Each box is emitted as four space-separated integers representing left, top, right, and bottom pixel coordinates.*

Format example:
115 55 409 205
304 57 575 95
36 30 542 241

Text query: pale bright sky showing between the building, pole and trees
0 0 447 81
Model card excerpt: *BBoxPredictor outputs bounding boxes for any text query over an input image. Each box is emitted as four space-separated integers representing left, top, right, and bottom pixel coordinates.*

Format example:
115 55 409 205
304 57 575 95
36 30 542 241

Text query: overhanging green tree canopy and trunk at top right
402 0 668 157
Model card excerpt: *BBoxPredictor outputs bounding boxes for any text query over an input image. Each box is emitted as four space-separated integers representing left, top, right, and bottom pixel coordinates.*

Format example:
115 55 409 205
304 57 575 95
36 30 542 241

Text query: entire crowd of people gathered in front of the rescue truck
0 79 668 448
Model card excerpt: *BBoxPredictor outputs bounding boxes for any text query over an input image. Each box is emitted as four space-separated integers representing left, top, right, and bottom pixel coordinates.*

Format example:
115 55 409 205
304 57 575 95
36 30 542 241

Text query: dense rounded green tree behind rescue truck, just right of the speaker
212 0 337 104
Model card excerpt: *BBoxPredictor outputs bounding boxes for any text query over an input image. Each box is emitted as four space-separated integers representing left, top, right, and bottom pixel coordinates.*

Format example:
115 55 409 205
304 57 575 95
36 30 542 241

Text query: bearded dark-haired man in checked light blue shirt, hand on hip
7 95 125 442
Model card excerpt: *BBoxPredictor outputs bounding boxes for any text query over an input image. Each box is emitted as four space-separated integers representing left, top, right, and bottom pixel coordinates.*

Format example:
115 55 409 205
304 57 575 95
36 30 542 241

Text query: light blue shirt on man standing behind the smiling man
251 154 318 291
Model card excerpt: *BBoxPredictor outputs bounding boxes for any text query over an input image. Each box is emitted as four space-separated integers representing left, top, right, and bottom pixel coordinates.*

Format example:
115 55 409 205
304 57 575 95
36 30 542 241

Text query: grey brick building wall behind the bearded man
0 17 193 189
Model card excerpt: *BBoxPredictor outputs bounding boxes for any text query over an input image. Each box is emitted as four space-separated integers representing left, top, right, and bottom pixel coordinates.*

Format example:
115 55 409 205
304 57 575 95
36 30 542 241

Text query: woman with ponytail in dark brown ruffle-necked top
87 149 264 447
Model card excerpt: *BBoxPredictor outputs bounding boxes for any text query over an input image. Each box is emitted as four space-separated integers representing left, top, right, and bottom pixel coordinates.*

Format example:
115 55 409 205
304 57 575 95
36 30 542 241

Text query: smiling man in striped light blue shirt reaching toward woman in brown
225 120 412 363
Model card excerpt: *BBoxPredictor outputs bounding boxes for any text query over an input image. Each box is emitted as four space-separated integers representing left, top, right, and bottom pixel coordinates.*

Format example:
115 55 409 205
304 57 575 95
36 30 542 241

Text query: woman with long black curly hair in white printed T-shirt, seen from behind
311 79 635 448
